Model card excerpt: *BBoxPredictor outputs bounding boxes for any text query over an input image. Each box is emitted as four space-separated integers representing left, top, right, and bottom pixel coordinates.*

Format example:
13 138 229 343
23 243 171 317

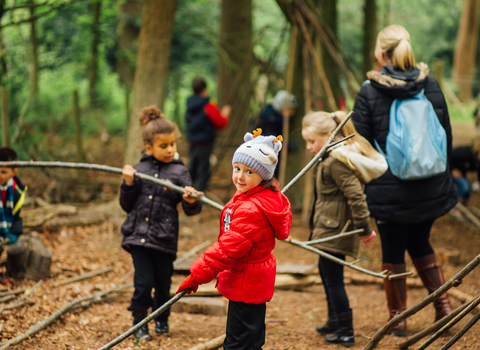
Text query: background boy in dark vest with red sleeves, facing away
185 77 231 191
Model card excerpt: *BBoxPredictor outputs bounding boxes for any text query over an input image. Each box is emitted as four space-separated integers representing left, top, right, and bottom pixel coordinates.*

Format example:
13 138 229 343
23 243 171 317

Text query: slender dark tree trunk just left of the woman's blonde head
362 0 377 77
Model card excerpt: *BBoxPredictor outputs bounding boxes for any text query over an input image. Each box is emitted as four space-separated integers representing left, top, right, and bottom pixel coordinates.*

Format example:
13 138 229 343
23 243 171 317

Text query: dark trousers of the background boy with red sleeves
188 145 212 191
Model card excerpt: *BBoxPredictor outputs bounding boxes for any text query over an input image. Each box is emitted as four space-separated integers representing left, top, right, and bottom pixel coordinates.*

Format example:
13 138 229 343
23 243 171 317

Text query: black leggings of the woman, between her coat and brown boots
377 220 435 264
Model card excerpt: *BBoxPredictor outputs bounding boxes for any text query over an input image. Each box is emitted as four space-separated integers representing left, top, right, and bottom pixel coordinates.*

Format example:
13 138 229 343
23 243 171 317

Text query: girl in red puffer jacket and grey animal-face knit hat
177 129 292 350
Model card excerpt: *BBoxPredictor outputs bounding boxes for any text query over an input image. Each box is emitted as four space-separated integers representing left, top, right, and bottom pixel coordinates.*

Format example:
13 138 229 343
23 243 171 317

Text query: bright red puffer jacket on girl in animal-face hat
190 186 292 304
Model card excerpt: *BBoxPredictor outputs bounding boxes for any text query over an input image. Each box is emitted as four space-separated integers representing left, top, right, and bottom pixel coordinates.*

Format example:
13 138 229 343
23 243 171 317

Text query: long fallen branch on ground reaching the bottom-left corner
0 270 133 350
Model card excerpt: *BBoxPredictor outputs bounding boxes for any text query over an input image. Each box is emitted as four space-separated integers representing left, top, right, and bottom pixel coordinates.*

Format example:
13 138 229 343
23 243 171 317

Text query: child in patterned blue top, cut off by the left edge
0 147 27 247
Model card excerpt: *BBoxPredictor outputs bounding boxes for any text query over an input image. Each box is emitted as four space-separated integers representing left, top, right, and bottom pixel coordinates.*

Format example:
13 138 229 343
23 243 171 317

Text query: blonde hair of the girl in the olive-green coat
302 111 377 157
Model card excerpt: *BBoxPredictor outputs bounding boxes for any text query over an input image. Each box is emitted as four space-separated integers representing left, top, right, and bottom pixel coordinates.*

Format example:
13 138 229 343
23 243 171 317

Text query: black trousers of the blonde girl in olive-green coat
318 253 350 315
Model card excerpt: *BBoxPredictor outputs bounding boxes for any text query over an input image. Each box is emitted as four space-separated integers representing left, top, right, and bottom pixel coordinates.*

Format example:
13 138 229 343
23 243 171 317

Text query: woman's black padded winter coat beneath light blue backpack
352 64 457 223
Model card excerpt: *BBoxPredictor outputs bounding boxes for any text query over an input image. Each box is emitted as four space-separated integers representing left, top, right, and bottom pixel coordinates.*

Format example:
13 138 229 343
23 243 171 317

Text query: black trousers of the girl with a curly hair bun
128 246 175 321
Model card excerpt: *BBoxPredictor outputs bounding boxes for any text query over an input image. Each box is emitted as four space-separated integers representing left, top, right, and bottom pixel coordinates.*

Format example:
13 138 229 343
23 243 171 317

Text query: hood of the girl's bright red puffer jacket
235 186 292 240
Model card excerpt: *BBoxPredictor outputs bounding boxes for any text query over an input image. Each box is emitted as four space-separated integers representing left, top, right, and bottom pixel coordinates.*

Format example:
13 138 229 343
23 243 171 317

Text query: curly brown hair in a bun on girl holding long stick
138 106 177 145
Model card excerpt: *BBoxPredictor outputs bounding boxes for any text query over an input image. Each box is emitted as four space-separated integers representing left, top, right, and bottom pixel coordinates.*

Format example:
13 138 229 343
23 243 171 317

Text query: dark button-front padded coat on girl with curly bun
120 155 202 255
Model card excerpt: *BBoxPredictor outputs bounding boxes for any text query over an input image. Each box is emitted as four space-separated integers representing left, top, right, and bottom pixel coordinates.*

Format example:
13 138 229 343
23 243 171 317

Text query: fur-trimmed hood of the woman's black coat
367 63 430 99
